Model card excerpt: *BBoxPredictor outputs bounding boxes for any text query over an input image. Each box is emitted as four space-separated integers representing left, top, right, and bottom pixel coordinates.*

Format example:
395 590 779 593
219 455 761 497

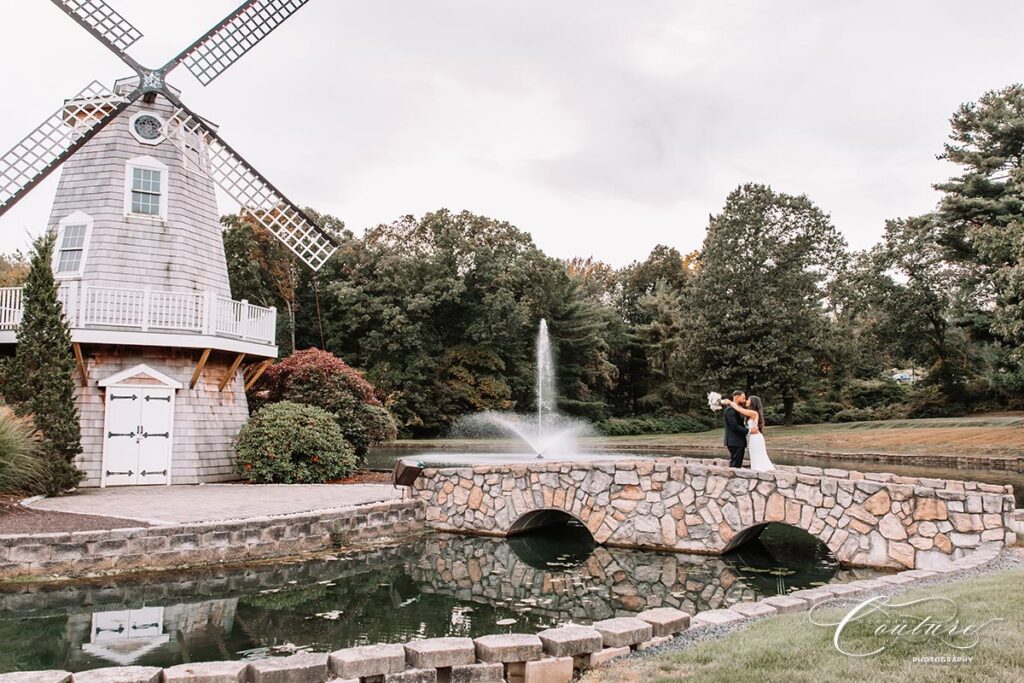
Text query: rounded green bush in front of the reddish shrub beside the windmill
234 401 355 483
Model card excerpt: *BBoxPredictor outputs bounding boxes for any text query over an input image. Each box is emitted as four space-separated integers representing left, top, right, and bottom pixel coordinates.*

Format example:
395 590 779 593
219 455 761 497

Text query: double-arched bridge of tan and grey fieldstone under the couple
412 458 1014 569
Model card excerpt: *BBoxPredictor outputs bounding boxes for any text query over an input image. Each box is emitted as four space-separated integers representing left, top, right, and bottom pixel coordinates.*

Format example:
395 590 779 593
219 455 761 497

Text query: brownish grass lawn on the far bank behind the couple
399 413 1024 457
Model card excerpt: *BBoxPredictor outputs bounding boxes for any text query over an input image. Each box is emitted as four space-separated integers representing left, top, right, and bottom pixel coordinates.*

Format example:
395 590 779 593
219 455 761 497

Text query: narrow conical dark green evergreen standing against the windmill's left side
4 233 83 495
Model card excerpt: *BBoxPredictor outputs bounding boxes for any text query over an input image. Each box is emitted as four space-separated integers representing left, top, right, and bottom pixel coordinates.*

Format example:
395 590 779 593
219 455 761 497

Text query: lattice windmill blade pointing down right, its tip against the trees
167 106 338 270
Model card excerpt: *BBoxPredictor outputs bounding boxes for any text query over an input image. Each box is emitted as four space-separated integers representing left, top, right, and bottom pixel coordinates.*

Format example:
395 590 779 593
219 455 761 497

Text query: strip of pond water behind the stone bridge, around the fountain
368 447 1024 508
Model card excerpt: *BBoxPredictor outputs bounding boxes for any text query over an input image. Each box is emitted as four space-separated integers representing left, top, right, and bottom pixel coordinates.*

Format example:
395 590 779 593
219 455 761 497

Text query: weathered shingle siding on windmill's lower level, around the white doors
77 346 249 486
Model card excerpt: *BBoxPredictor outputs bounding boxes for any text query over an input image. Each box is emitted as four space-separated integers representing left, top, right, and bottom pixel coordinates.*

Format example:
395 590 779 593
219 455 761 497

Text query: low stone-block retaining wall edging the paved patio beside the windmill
0 501 423 581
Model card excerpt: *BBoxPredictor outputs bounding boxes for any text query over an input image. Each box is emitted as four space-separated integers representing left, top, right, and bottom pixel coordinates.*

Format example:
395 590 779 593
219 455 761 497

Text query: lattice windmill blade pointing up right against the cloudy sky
164 0 309 85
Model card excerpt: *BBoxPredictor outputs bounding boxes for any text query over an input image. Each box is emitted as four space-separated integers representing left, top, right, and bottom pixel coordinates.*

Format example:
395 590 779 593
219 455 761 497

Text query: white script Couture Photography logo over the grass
808 595 1005 664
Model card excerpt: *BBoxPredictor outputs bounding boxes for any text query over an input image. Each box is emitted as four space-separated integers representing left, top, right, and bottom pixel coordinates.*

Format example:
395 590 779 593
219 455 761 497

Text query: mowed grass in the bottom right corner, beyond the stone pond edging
582 569 1024 683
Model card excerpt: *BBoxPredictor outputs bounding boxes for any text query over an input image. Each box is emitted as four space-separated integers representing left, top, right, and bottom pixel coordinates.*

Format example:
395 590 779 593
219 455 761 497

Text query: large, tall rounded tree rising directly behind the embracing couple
687 184 846 424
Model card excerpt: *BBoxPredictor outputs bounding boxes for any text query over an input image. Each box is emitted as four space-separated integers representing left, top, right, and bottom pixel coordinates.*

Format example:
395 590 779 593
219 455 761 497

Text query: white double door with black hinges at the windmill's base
103 386 174 486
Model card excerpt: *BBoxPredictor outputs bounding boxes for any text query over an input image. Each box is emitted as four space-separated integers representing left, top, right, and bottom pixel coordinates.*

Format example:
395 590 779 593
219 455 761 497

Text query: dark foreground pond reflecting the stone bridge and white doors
0 524 880 672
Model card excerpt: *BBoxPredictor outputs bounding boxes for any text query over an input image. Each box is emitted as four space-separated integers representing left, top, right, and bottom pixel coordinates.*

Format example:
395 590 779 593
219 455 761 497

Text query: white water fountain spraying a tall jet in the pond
453 318 593 458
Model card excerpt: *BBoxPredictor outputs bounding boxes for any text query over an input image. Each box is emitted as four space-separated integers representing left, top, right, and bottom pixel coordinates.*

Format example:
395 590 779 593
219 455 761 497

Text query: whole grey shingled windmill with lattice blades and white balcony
0 0 337 485
